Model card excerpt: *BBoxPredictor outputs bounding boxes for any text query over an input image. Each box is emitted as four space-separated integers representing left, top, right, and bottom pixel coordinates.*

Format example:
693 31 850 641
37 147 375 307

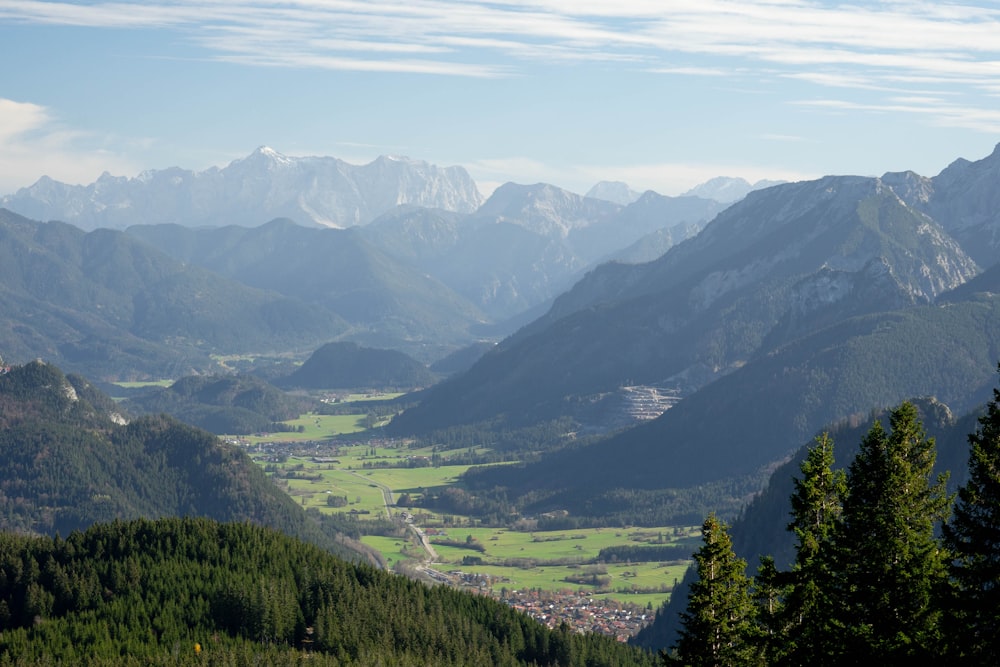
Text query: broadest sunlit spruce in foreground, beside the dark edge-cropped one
834 403 950 664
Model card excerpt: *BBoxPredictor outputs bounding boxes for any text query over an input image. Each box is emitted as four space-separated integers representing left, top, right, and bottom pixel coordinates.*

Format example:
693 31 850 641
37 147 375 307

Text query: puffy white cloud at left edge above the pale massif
0 98 137 194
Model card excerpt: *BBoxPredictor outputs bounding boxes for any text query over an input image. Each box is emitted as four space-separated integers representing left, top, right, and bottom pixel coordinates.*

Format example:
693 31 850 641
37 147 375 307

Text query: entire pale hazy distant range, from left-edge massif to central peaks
0 147 736 363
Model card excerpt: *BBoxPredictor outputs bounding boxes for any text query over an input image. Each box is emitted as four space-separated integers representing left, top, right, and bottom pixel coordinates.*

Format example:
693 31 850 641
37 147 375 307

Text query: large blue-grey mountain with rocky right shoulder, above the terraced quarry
392 167 980 428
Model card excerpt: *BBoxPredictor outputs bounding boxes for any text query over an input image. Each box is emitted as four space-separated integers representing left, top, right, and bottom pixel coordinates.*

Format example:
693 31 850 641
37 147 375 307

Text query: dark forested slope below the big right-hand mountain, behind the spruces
458 294 1000 525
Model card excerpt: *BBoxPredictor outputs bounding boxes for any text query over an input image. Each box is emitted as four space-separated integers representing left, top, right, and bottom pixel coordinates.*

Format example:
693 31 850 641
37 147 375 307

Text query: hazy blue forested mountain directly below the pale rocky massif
127 219 485 354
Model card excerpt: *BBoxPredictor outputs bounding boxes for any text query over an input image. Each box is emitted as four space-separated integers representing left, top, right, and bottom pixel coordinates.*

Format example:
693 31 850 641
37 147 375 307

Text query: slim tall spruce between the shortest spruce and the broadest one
774 433 847 667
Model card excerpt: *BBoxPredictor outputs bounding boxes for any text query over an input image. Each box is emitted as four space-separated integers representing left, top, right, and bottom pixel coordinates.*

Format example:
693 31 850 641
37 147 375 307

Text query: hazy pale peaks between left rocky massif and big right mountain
359 183 723 320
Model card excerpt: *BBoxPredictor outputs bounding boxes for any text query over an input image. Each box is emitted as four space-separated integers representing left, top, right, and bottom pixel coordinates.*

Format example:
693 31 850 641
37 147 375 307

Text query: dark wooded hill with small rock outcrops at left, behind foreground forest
0 362 357 557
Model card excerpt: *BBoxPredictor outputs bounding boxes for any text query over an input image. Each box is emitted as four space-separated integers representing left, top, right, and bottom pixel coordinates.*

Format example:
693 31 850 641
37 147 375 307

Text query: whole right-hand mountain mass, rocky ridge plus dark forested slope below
389 142 1000 519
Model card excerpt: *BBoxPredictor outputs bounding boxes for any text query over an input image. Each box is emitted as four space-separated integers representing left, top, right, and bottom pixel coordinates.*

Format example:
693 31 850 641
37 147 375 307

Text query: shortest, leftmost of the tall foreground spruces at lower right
664 513 758 667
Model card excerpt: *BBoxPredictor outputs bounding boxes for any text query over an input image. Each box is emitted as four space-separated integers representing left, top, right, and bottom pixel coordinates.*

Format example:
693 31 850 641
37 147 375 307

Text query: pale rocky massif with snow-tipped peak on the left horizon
0 147 482 229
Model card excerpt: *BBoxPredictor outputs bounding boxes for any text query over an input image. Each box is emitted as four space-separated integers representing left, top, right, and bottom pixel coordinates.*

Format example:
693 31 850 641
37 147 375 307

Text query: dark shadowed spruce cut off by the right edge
943 368 1000 665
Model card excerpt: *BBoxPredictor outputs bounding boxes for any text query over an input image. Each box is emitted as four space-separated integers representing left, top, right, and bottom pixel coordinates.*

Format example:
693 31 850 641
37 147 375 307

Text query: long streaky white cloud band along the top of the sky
0 0 1000 77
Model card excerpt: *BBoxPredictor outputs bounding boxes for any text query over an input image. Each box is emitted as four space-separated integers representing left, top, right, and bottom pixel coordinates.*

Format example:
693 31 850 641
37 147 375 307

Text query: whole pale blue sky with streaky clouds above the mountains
0 0 1000 195
